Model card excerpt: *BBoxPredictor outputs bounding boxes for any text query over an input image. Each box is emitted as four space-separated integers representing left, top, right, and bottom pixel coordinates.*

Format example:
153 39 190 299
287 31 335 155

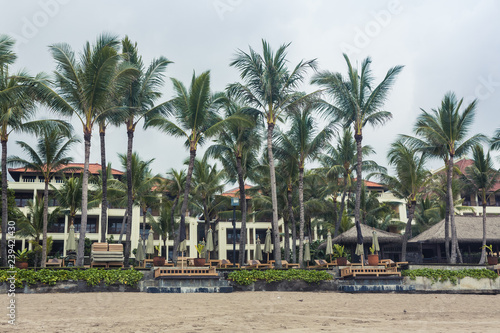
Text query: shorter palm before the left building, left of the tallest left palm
9 128 79 267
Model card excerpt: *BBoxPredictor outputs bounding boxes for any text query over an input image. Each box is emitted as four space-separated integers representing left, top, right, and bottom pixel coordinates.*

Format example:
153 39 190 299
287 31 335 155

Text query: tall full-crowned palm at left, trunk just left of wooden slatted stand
41 34 137 266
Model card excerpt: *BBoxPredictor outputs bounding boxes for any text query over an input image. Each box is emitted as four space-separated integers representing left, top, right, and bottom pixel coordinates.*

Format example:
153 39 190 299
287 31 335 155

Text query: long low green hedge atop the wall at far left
0 268 144 288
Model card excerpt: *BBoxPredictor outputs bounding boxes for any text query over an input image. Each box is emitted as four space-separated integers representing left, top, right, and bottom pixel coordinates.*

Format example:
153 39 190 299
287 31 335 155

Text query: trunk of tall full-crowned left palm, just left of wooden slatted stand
76 130 92 266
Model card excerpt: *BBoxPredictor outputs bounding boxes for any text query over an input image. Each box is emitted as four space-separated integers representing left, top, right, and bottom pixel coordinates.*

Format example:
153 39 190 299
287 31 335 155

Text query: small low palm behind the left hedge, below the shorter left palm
16 198 61 267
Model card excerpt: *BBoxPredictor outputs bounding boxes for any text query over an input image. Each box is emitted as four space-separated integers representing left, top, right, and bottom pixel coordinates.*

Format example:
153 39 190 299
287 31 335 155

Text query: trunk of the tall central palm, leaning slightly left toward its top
267 122 282 268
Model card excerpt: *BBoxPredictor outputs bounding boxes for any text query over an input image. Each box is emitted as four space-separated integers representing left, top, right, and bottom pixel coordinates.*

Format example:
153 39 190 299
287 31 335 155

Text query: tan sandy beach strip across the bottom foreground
0 292 500 333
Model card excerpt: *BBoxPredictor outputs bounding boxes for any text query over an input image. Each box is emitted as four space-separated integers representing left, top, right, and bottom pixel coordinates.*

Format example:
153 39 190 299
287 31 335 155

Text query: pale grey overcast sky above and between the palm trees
0 0 500 182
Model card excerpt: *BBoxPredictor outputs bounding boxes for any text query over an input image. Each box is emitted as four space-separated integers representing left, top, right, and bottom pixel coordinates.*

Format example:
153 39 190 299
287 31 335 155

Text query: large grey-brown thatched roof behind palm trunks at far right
409 215 500 244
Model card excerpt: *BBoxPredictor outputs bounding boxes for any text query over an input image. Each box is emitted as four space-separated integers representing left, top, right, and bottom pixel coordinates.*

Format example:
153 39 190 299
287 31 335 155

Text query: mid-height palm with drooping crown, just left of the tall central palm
205 97 261 266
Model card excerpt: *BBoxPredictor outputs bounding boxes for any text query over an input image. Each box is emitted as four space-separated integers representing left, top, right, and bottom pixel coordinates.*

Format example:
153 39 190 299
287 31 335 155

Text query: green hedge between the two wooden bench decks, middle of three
228 269 333 286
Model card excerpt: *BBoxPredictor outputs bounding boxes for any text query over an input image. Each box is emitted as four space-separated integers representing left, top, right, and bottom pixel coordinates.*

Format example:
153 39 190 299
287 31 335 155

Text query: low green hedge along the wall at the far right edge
401 268 498 284
